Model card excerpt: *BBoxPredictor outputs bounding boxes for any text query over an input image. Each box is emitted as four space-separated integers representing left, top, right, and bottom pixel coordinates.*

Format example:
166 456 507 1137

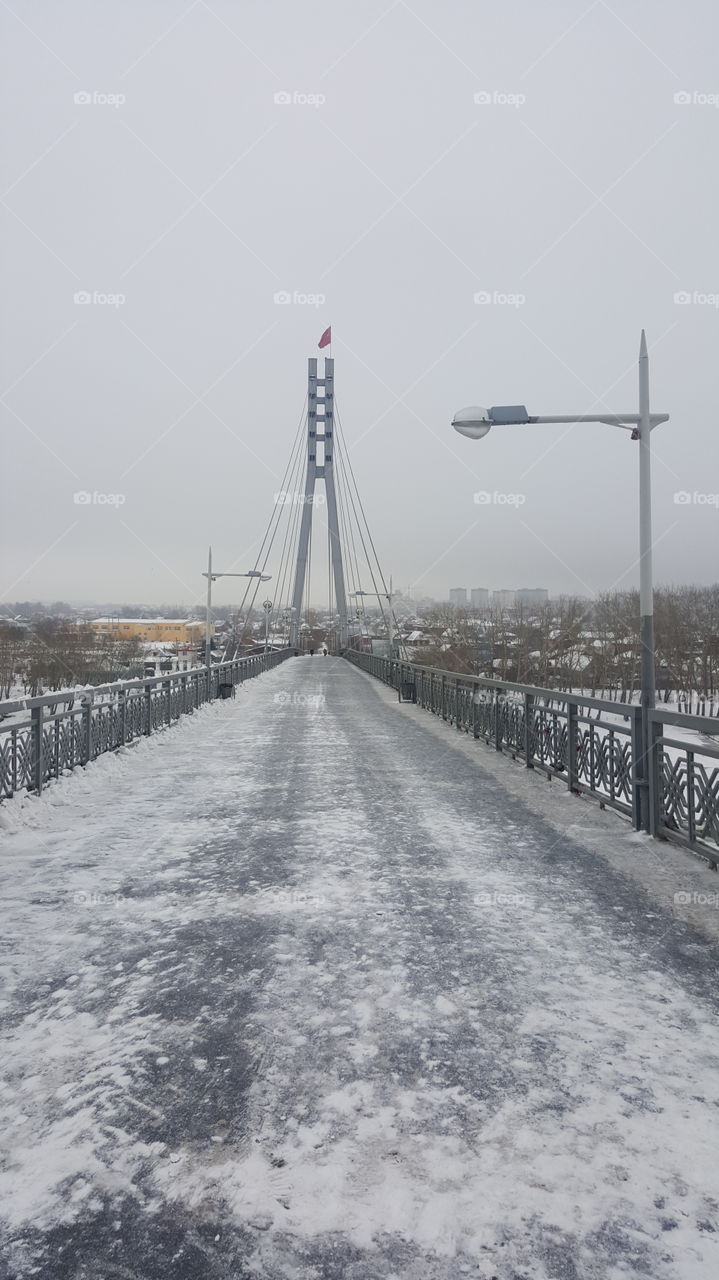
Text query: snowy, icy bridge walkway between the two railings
0 657 719 1280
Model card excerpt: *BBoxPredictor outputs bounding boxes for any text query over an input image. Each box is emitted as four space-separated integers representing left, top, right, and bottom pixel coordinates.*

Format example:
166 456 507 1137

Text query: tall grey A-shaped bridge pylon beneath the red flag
290 357 348 649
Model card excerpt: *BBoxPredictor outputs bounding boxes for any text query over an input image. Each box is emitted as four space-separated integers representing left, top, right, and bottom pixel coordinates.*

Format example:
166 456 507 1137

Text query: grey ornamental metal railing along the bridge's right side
344 649 719 868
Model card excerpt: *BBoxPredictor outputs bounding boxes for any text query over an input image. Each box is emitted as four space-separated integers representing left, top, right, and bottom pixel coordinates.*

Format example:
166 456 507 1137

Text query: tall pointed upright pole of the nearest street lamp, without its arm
638 329 656 831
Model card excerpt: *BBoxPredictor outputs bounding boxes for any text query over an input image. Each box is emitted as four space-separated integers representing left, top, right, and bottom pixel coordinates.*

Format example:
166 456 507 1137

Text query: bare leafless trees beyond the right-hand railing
415 585 719 714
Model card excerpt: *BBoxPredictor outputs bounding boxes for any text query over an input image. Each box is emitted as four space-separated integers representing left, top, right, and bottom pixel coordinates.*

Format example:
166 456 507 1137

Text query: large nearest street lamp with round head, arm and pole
452 329 669 818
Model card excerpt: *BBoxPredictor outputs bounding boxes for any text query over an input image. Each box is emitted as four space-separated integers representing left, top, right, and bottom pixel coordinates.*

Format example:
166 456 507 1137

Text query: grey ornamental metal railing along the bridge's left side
0 649 294 800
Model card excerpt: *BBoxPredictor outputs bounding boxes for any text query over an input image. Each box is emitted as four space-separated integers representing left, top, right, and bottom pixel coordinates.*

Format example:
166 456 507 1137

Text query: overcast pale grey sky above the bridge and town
0 0 719 603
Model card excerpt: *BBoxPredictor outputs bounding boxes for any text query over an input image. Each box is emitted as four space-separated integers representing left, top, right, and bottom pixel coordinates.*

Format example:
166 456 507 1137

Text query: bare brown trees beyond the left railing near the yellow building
0 617 143 699
